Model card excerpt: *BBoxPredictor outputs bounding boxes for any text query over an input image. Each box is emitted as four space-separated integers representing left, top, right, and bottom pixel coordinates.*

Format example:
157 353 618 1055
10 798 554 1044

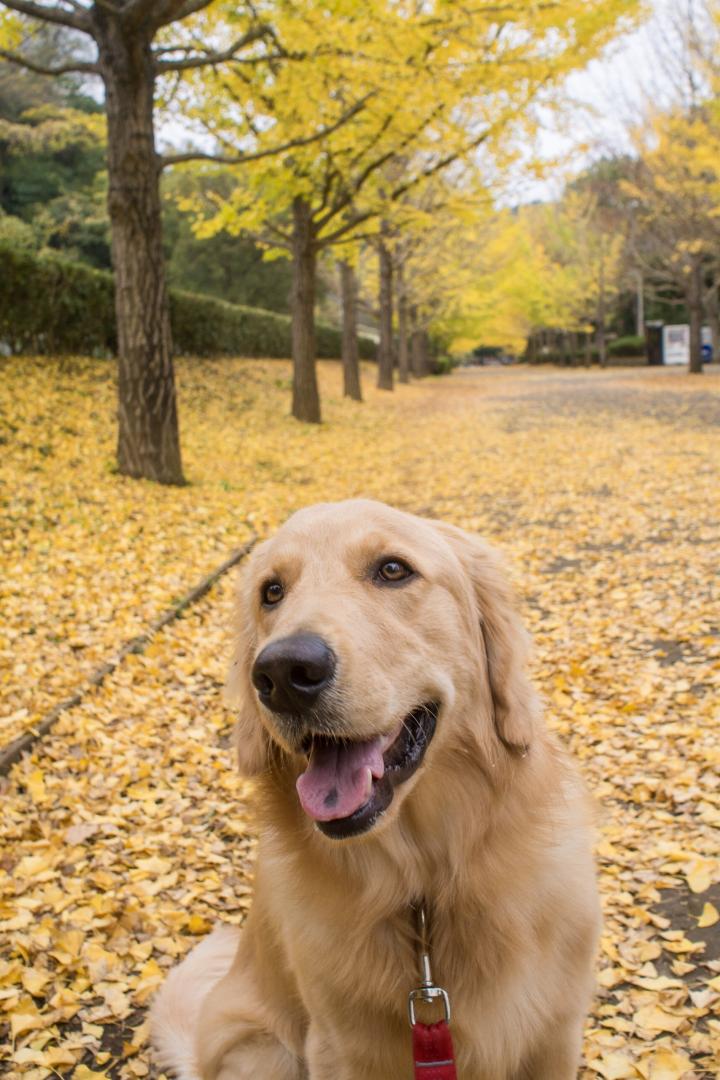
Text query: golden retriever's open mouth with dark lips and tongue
297 702 439 839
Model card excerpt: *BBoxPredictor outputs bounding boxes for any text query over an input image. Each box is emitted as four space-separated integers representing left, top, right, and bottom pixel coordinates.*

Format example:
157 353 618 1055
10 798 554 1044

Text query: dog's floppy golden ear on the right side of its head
431 523 540 754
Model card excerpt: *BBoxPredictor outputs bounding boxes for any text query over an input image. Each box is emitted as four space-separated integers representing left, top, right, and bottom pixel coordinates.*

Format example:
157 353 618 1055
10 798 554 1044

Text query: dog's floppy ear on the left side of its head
225 565 269 777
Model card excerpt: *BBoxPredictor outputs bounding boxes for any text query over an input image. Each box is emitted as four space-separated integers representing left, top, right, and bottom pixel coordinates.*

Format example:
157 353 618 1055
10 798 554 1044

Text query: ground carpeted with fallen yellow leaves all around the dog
0 361 720 1080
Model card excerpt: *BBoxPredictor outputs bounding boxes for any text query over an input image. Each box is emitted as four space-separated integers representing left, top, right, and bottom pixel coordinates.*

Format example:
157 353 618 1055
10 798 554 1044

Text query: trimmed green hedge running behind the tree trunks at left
0 245 376 360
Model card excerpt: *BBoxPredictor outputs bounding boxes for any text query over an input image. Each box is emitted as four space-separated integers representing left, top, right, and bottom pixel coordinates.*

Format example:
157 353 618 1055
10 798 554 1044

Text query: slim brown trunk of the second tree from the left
293 195 321 423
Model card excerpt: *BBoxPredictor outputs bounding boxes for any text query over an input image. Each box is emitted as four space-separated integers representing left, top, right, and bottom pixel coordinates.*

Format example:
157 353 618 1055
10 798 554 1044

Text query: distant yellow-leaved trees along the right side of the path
463 0 720 374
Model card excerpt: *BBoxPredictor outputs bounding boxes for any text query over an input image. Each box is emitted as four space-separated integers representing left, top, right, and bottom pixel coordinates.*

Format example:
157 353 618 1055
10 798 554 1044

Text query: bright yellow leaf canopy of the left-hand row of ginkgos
173 0 642 349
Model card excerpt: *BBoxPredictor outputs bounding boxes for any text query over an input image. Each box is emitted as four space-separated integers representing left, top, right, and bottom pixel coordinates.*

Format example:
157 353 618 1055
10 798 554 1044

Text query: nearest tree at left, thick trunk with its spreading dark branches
0 0 358 484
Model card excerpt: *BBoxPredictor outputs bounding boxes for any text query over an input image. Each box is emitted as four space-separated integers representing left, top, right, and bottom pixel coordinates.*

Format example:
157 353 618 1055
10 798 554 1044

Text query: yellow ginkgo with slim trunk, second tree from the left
177 0 640 421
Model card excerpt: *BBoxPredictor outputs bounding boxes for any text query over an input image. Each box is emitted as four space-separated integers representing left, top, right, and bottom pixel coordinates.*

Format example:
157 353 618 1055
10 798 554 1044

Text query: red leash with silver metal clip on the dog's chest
408 903 458 1080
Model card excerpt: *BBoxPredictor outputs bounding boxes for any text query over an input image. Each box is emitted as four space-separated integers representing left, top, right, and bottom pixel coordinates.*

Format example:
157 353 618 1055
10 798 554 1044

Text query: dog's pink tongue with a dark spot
297 738 384 821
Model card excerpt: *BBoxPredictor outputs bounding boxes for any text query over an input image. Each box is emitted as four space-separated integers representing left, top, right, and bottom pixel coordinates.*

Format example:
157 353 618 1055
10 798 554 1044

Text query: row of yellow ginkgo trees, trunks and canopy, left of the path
0 0 639 483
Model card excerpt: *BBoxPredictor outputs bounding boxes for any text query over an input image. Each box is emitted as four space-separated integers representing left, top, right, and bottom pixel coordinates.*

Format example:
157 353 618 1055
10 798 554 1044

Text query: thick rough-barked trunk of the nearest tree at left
95 11 184 484
